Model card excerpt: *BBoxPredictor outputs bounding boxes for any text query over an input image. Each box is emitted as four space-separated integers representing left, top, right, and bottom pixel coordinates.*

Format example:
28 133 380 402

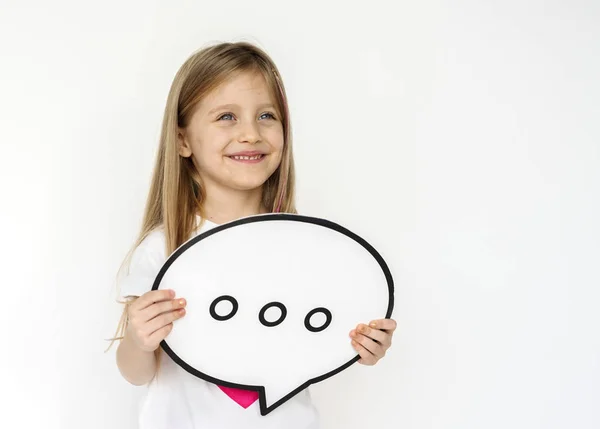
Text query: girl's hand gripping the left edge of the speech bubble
127 290 186 352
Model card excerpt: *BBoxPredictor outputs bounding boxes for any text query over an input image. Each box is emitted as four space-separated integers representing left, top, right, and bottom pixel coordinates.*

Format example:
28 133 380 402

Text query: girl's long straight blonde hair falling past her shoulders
108 42 296 354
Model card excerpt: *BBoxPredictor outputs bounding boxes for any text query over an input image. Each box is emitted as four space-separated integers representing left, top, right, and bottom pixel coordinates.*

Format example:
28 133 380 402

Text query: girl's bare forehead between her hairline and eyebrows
200 72 274 109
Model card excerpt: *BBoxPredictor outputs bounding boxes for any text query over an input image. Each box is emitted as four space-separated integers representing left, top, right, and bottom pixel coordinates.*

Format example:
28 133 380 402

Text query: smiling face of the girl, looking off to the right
179 72 283 193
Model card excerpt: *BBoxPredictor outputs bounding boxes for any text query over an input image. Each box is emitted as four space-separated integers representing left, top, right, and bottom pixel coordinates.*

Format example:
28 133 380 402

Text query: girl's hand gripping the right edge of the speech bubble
350 319 396 365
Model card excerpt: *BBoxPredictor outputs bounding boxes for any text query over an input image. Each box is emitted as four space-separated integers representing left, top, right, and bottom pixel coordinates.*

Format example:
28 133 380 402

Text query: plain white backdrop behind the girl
0 0 600 429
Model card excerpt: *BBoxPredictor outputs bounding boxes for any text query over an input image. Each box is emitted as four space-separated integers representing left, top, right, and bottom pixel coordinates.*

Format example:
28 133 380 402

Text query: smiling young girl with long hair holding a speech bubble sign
111 43 396 429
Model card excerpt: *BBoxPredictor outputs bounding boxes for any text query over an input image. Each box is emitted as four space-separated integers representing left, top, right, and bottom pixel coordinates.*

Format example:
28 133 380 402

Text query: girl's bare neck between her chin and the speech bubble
203 187 267 224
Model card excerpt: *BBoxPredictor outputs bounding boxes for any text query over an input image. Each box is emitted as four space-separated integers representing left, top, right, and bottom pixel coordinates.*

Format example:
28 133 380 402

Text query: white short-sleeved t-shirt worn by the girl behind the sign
120 218 319 429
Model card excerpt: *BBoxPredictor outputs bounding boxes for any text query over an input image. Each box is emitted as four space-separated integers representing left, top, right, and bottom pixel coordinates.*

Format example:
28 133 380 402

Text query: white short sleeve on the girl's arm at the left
118 232 166 301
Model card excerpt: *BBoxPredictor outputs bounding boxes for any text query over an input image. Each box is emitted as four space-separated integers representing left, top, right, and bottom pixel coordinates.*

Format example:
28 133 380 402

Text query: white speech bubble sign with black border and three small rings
152 214 394 416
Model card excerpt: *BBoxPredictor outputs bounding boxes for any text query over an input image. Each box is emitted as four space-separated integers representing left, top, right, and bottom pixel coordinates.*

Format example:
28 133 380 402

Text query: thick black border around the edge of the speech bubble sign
152 213 394 416
